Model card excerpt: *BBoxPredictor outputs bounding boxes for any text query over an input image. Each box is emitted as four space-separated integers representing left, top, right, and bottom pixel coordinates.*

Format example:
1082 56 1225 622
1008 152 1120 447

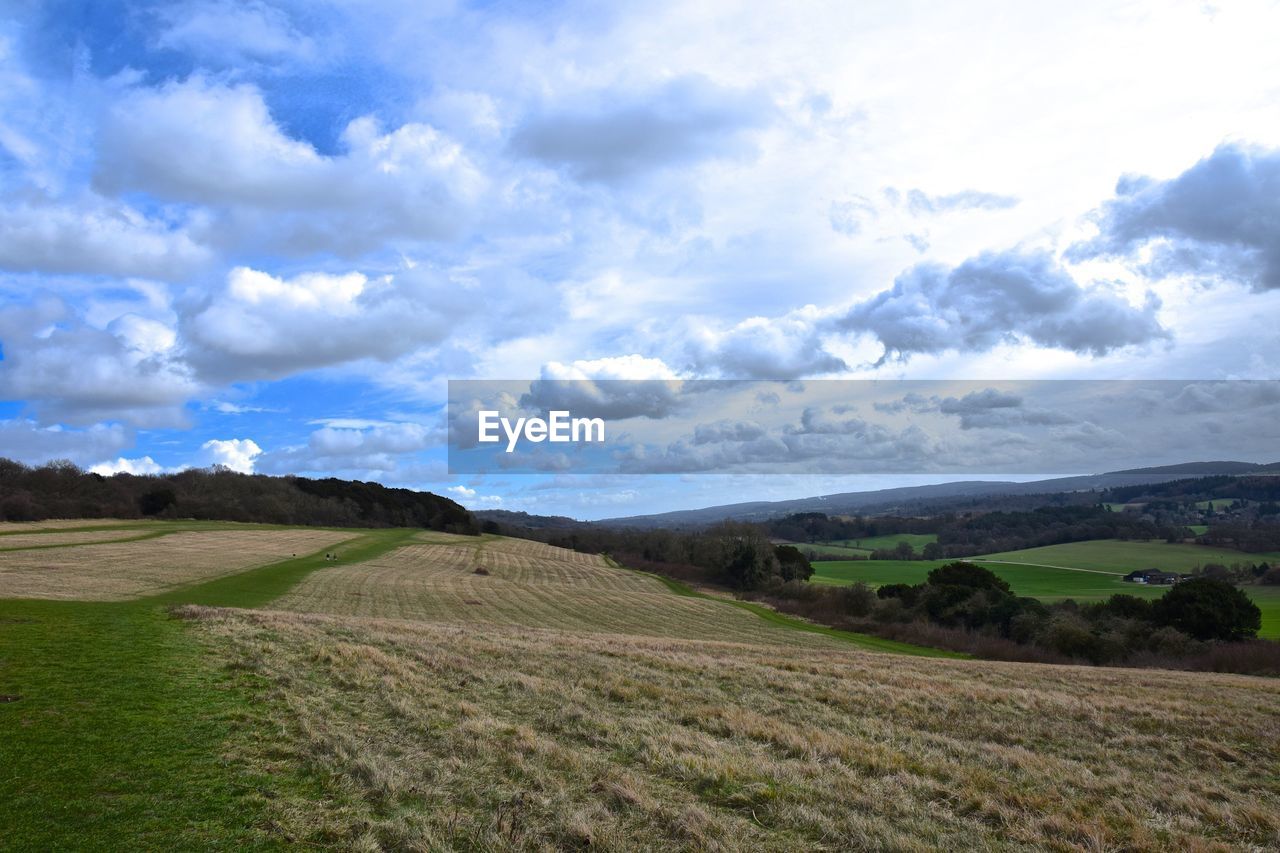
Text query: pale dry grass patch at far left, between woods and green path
0 529 352 601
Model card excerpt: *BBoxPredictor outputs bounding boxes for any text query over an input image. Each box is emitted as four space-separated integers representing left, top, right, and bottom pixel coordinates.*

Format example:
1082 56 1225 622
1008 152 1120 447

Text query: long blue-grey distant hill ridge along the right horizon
596 461 1280 528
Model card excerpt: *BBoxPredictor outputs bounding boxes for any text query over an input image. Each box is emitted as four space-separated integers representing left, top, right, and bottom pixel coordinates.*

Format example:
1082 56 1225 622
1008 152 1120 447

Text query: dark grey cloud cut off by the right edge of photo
1066 145 1280 291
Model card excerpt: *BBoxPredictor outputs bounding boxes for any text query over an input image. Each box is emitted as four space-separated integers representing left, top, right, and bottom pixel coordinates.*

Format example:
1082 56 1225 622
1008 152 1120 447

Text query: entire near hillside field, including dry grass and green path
0 523 1280 850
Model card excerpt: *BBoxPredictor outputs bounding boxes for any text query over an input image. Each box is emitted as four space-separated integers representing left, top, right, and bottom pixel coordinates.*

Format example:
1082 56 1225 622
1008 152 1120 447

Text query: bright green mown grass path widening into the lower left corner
0 522 415 850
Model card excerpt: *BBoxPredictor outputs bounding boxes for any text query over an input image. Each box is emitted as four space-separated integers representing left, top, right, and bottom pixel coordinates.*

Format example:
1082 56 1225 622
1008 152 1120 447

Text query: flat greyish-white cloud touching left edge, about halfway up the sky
0 195 211 279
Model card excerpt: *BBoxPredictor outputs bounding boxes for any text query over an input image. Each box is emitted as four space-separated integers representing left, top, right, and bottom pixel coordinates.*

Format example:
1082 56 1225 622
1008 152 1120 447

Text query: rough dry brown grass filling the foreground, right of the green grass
186 608 1280 850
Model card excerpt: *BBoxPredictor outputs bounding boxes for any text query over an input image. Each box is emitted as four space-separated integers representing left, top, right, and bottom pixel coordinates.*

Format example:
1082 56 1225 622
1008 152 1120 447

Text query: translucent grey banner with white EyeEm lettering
448 379 1280 475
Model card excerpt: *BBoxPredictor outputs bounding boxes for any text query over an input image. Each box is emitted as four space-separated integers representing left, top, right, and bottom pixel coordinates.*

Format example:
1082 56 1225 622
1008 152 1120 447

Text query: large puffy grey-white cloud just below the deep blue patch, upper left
95 77 485 255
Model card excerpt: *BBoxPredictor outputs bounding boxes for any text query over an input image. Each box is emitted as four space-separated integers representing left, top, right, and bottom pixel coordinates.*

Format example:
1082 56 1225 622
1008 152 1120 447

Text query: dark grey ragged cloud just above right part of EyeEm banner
835 251 1169 364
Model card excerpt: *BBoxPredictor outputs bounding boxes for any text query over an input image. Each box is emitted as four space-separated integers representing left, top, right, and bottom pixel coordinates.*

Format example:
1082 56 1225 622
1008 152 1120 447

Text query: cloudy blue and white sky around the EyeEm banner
0 0 1280 517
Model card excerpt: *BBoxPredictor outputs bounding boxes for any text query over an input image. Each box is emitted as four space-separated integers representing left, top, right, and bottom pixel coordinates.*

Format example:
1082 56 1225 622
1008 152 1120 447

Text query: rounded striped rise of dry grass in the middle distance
274 534 838 647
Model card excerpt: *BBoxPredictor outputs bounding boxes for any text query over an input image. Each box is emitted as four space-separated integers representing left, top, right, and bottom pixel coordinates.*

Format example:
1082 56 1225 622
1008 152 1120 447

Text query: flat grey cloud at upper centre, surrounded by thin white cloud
511 77 773 182
